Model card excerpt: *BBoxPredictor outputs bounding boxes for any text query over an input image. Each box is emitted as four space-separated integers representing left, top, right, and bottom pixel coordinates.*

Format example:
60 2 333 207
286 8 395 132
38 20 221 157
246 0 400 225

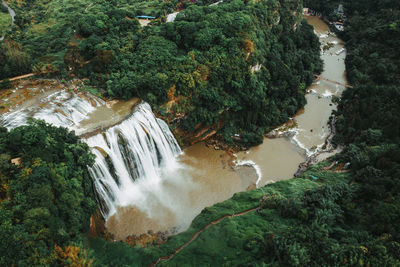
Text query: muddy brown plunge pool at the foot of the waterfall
106 143 257 240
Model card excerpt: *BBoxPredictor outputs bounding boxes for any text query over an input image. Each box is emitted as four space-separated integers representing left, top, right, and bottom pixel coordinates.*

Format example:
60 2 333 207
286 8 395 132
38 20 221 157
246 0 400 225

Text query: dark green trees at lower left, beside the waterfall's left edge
0 121 96 266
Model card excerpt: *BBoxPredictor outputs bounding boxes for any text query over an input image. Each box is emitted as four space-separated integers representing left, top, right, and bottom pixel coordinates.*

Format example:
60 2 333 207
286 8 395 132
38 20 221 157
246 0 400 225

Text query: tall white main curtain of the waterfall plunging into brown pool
85 103 181 219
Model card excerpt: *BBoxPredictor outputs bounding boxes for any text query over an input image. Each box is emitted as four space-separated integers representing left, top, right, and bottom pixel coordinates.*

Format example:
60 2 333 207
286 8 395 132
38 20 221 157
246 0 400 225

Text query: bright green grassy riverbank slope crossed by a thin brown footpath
150 162 349 266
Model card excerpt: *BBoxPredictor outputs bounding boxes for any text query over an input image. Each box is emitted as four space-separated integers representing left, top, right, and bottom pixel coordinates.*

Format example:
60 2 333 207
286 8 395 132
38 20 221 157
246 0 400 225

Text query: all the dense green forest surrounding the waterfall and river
0 0 400 266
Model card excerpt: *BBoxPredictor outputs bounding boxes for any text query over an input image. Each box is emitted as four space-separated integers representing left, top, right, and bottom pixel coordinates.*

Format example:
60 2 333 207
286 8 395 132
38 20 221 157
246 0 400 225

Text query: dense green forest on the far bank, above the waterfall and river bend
0 0 322 145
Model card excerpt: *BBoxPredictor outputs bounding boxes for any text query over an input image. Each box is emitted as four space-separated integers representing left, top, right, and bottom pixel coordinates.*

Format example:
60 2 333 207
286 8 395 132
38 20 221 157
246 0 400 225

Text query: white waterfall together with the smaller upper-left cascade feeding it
0 90 183 222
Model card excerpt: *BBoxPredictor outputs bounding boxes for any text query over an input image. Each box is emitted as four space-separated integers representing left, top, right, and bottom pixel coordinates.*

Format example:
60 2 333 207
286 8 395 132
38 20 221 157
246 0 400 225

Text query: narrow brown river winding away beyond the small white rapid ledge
238 16 346 186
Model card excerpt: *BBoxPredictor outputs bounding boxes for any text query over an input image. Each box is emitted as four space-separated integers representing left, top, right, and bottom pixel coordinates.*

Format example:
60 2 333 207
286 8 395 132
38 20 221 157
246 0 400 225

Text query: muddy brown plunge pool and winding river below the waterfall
106 17 346 239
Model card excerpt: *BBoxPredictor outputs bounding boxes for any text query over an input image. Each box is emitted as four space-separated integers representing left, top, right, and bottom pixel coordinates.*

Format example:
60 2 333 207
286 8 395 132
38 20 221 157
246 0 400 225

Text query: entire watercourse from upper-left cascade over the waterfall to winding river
0 17 346 240
